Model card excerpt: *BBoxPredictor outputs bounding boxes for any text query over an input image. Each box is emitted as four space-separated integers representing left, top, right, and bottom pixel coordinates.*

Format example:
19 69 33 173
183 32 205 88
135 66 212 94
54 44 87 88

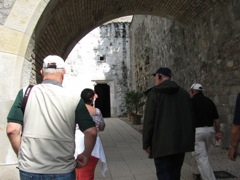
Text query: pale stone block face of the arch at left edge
0 0 48 180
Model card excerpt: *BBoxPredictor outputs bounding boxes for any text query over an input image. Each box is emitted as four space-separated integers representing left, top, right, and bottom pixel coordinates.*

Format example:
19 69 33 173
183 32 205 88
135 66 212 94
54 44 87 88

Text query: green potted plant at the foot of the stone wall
125 91 144 124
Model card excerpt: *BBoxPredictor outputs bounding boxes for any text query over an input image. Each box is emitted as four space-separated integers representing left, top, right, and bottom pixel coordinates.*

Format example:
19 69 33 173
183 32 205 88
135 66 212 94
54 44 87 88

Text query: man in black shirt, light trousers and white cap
189 83 221 180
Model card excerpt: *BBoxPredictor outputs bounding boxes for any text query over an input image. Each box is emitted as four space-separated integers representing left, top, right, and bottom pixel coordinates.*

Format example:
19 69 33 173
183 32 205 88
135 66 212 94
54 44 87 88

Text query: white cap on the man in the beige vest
43 55 65 69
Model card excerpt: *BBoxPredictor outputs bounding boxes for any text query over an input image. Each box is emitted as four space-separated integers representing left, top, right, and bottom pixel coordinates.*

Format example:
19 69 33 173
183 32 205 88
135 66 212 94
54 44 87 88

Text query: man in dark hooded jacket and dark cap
143 68 195 180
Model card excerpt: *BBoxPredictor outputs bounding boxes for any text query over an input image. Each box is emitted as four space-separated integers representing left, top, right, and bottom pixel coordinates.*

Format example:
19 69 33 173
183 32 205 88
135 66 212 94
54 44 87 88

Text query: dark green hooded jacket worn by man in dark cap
143 80 195 158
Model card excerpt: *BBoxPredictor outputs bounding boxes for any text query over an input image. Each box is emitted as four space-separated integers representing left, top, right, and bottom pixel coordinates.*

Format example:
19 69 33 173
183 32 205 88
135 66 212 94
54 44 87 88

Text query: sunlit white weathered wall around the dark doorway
63 22 130 117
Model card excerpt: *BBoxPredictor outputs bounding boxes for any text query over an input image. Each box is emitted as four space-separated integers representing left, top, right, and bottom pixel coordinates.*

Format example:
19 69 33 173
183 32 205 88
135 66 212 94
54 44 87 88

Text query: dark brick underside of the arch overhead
32 0 225 65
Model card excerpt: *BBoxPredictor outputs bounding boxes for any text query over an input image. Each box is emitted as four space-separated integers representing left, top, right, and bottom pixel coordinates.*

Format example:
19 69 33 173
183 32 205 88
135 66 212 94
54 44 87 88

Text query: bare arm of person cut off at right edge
228 124 240 161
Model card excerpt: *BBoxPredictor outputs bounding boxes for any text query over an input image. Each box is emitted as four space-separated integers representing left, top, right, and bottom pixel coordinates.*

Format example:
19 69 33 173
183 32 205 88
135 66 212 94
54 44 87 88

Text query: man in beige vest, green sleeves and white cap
6 55 97 180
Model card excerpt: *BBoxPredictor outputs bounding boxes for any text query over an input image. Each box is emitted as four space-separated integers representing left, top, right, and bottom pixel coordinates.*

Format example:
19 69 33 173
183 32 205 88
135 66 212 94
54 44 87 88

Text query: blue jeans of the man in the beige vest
19 170 76 180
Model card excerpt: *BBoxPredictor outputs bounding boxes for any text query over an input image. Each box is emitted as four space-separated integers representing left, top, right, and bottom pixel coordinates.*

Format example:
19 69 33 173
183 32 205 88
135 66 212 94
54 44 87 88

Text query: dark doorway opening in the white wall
94 83 111 117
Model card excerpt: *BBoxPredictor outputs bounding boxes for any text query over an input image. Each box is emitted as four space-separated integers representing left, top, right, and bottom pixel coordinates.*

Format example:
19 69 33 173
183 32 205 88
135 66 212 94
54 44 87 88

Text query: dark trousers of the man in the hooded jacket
154 153 185 180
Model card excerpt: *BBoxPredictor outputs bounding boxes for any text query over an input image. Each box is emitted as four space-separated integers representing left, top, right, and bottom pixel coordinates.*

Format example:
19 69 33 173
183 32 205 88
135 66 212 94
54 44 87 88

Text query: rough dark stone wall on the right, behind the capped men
130 1 240 147
